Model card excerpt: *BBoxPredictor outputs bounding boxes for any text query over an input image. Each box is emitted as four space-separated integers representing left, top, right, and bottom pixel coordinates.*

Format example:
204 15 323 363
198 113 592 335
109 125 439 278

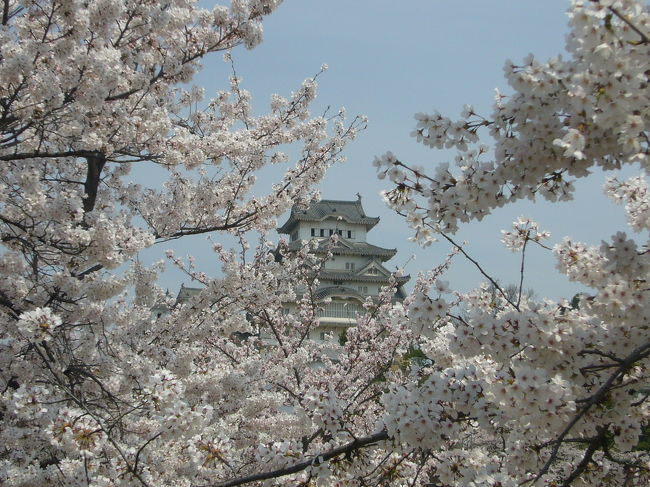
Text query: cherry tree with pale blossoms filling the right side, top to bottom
375 0 650 486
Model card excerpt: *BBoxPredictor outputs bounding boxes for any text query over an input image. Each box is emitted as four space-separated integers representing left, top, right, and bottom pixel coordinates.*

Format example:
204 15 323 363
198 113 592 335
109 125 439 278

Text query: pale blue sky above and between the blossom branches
151 0 636 299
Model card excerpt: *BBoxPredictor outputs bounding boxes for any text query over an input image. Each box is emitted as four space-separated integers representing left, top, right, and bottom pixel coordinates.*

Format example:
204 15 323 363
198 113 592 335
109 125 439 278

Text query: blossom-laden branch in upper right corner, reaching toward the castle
375 0 650 242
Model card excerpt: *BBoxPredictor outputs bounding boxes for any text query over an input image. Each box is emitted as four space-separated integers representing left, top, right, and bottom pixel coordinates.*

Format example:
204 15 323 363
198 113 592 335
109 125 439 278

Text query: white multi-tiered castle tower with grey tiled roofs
278 195 409 340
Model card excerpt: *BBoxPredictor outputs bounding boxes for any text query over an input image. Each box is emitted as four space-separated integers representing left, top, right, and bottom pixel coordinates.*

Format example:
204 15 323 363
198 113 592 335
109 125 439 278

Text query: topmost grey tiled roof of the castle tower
278 197 379 233
